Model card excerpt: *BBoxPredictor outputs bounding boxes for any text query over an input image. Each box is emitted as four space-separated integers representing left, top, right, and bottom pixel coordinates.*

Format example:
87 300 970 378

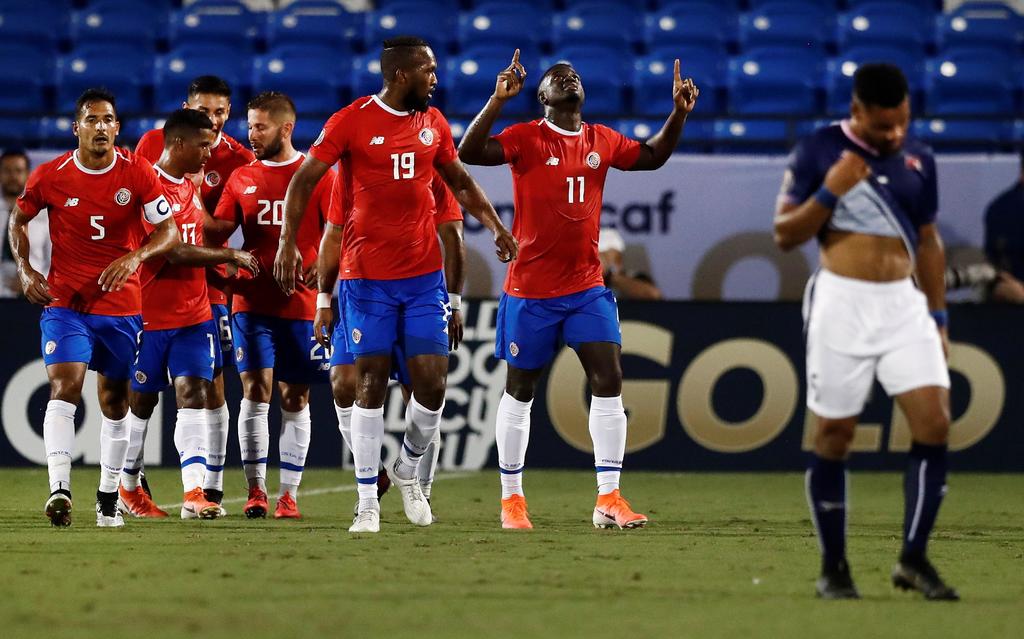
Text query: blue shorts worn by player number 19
339 270 452 357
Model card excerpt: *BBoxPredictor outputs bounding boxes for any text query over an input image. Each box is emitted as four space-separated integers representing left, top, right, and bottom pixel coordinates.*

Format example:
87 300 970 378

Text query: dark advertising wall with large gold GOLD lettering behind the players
0 300 1024 471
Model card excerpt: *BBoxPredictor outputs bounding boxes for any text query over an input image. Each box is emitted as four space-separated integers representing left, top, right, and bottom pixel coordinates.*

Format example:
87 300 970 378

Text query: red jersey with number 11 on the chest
496 120 640 299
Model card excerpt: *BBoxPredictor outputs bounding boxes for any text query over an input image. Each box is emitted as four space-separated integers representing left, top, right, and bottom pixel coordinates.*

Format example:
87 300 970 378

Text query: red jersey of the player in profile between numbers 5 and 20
140 167 213 331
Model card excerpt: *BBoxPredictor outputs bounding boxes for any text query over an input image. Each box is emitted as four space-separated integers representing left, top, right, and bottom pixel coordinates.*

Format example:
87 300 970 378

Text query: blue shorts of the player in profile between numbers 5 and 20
131 320 220 392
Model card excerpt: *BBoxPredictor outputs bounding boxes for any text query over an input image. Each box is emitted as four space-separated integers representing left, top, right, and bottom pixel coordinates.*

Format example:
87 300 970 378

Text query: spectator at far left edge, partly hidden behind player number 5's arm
0 148 50 298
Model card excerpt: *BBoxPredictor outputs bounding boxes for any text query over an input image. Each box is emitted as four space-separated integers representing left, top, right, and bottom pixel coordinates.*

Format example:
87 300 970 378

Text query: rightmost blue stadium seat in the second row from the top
926 47 1020 116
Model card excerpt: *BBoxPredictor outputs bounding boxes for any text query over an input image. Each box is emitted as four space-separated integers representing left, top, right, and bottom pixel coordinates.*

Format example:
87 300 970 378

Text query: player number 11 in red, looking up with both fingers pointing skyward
459 49 698 528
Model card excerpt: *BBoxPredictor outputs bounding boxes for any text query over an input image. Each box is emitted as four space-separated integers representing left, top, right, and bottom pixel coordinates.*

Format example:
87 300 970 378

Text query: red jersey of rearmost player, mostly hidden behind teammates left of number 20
135 129 256 304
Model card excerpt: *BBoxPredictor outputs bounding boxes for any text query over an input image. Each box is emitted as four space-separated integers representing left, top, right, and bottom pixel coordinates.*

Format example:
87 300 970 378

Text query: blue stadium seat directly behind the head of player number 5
56 44 154 115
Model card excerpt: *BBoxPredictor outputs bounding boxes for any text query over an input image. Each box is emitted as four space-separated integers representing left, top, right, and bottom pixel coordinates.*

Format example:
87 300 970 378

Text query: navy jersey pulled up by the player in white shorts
779 120 938 257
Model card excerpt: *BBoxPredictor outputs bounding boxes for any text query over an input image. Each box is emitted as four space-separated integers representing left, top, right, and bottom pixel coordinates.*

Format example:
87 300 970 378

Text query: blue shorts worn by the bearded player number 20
231 312 331 384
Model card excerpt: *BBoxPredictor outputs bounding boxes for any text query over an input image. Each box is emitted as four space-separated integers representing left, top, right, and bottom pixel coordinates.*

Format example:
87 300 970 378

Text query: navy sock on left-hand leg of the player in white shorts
806 455 846 571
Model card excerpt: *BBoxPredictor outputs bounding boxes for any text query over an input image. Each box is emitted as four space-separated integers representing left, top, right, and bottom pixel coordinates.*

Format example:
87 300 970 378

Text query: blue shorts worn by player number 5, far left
39 307 142 381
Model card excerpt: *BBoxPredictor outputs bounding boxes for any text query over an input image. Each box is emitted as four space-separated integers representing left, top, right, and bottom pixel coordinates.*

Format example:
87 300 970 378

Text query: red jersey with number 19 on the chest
309 95 458 280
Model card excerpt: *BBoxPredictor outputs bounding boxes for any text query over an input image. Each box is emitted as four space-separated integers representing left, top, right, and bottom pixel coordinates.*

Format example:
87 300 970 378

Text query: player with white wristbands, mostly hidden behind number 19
313 174 466 514
